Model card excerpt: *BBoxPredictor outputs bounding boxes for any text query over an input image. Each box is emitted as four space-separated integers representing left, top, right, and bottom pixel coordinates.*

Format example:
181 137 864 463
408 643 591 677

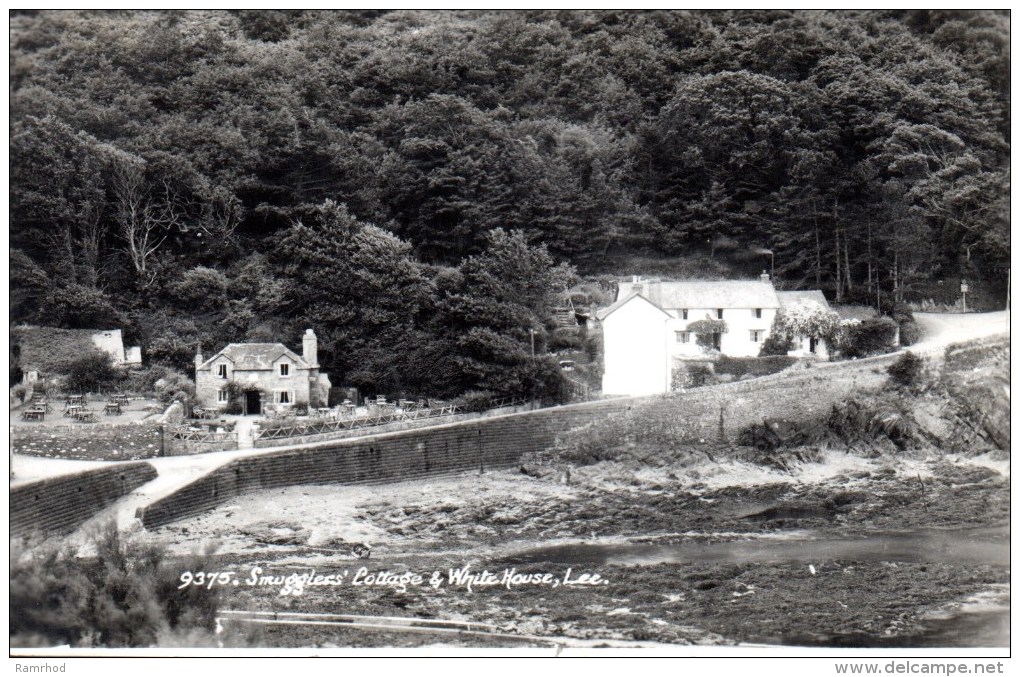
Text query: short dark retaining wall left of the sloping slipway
10 463 156 536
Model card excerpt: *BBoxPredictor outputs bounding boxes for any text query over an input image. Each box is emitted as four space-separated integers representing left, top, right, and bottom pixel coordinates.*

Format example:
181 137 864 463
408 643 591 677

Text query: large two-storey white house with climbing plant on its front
596 274 827 395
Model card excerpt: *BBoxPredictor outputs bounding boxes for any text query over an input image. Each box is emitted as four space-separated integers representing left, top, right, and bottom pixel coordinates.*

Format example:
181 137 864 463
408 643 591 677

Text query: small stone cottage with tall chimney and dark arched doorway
195 329 329 415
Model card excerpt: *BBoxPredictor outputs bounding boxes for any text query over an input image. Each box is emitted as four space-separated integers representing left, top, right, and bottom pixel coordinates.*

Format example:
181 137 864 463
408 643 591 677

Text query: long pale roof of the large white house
617 279 779 310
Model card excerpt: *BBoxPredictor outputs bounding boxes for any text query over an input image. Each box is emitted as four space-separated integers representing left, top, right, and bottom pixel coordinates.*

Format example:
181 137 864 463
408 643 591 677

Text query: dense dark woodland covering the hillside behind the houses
10 10 1010 394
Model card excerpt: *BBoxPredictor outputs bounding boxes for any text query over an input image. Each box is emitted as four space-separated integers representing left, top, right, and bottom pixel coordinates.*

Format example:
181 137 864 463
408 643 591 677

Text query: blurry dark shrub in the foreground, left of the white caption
10 523 219 647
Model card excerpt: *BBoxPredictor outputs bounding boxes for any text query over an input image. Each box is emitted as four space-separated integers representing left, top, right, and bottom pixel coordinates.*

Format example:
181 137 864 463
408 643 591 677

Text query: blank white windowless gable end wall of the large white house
602 297 672 395
